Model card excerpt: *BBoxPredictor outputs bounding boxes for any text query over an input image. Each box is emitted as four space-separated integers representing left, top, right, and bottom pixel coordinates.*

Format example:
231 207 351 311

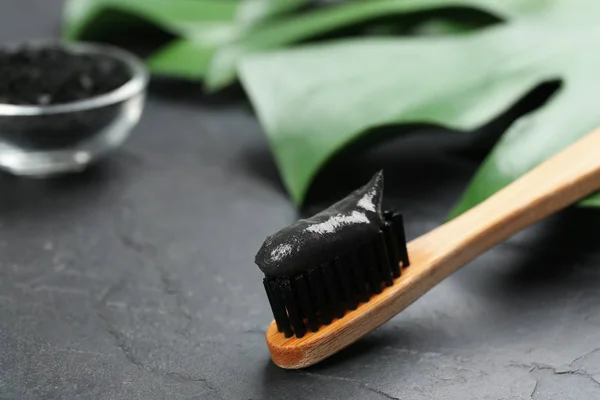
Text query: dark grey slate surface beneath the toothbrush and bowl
0 0 600 400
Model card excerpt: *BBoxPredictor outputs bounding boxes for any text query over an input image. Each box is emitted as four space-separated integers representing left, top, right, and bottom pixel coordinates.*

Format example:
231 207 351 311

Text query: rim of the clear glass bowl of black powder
0 40 150 116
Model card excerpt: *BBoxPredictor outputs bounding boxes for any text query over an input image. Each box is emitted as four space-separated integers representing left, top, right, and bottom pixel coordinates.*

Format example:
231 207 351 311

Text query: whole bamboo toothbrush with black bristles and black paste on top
257 129 600 369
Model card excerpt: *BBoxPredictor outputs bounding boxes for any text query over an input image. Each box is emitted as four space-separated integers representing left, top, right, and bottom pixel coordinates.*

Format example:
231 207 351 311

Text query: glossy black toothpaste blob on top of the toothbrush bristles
255 171 384 276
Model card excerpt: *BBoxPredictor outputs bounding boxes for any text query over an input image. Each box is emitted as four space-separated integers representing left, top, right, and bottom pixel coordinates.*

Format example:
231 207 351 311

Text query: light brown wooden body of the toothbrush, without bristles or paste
266 129 600 368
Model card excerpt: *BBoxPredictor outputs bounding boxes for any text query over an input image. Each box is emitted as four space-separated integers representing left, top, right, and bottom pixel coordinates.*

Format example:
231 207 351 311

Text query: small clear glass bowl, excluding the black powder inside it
0 42 149 177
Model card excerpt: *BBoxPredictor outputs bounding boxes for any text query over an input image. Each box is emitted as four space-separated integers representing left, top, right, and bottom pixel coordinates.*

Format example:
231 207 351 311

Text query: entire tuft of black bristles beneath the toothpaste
263 212 409 338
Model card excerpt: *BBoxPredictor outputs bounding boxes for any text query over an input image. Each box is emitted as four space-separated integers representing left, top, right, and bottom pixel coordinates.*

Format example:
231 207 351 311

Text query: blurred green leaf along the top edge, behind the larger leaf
65 0 492 85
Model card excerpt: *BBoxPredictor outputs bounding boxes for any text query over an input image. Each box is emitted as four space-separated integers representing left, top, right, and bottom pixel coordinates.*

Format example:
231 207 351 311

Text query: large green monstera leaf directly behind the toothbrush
240 0 600 215
